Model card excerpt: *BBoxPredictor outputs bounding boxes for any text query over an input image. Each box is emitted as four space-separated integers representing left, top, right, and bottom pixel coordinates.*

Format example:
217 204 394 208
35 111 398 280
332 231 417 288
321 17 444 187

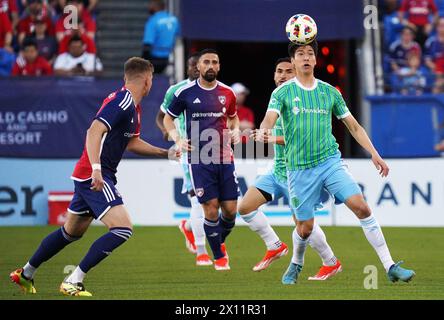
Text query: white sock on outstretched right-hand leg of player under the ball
359 215 395 272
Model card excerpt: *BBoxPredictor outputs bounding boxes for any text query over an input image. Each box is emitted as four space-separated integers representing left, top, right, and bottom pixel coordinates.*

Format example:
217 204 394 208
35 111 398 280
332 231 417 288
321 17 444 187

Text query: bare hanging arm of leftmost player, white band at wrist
86 120 108 191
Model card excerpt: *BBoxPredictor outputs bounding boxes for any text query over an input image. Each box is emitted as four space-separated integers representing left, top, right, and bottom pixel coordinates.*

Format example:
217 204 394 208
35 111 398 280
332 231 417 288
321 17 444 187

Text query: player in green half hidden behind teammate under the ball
239 57 342 280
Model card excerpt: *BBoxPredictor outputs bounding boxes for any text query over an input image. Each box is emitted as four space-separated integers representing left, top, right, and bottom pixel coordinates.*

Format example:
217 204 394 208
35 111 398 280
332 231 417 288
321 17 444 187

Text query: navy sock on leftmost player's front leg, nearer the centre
79 227 133 273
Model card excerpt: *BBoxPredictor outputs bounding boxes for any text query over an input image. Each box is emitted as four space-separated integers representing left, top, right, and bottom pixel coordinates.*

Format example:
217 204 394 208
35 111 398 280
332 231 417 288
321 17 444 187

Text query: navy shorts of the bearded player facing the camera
189 163 240 203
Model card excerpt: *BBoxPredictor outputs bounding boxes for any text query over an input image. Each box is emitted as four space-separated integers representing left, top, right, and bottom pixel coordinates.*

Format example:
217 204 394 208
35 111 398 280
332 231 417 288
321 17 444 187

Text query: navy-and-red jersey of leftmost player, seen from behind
71 87 141 183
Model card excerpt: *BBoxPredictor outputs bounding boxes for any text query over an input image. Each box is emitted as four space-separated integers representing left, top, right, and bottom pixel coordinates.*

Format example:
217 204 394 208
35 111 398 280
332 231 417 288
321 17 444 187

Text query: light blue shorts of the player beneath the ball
287 152 362 221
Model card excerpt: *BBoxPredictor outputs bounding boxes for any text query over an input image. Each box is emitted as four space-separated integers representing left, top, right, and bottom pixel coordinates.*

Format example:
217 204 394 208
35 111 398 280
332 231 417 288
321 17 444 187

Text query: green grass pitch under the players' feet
0 227 444 300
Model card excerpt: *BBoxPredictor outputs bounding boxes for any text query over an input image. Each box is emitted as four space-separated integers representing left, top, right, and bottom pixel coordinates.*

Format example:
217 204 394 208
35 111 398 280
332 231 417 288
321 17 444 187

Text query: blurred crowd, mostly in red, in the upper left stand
0 0 103 76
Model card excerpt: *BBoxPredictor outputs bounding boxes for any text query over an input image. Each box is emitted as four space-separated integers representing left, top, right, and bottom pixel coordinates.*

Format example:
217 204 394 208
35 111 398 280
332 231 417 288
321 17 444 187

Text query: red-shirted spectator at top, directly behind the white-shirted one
55 0 96 42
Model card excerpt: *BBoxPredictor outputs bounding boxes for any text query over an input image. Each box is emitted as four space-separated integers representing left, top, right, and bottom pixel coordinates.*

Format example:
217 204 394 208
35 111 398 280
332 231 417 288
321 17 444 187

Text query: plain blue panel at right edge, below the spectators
367 94 444 157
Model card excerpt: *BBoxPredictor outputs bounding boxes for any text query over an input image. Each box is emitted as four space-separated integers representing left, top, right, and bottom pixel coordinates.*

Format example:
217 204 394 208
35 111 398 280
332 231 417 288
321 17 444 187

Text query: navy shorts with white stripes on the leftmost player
68 176 123 220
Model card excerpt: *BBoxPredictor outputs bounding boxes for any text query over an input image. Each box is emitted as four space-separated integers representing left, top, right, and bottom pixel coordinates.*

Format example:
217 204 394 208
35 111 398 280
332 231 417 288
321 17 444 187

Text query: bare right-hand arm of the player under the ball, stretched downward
341 114 389 177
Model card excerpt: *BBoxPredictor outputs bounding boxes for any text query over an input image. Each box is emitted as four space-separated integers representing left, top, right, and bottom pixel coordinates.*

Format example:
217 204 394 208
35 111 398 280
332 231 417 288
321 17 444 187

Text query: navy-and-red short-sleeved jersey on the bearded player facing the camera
167 80 236 163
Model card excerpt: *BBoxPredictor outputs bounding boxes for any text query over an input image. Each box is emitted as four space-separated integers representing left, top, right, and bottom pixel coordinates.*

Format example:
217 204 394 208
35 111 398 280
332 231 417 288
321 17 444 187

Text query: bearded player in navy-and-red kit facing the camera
164 49 240 270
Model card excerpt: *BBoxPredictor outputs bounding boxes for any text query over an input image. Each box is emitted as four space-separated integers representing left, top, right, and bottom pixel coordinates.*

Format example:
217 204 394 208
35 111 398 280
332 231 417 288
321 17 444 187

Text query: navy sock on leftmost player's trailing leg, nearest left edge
29 227 81 268
